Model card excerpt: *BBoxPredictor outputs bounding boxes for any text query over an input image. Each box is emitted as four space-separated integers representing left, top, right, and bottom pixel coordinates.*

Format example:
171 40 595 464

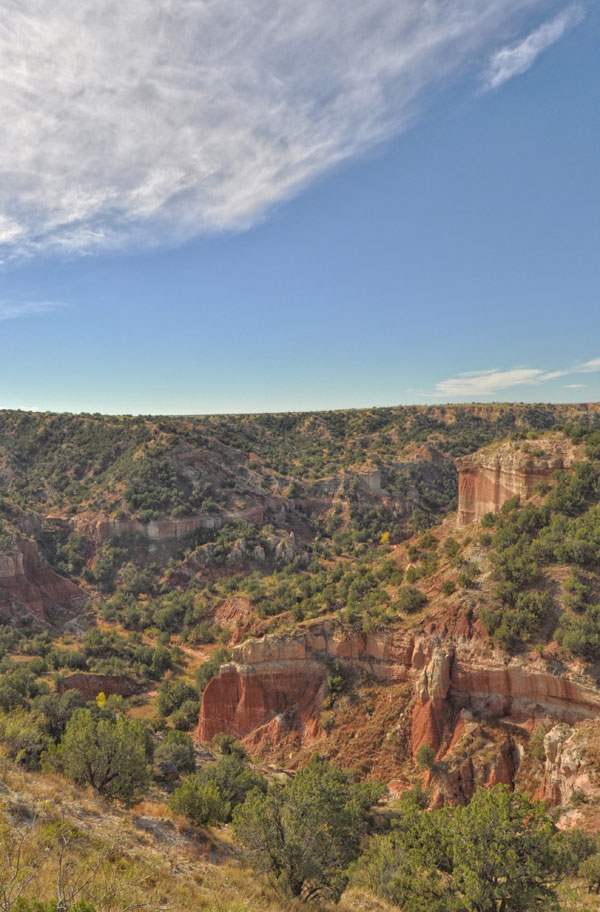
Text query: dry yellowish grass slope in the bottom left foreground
0 762 600 912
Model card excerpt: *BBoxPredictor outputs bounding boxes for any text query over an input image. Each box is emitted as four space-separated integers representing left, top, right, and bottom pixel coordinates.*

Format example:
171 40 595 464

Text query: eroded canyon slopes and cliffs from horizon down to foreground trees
0 405 600 827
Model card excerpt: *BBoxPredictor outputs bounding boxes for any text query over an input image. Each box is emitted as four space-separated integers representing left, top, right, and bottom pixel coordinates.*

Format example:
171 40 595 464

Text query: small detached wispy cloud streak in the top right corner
484 4 585 89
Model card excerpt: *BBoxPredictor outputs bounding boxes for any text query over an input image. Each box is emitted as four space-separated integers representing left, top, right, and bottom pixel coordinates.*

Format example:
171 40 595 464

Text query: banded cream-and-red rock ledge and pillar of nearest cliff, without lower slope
198 621 600 782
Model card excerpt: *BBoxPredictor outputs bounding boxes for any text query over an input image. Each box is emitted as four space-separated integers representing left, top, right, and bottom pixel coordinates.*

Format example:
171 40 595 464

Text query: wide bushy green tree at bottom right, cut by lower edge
358 785 564 912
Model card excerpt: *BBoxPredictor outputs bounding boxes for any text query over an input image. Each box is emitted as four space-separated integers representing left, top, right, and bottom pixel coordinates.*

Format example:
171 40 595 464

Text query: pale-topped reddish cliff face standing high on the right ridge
456 435 575 526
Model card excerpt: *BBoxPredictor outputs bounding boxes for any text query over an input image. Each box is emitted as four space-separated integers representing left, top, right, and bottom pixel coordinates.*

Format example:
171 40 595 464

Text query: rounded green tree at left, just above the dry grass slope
45 709 150 804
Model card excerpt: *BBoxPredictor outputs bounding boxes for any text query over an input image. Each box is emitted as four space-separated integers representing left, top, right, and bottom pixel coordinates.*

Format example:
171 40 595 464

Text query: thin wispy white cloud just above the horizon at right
434 358 600 397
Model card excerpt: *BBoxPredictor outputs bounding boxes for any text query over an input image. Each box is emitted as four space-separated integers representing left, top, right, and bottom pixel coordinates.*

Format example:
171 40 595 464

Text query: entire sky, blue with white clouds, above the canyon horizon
0 0 600 413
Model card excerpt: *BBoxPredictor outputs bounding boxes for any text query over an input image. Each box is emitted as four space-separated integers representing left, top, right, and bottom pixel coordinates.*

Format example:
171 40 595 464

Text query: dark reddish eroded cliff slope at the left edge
0 539 85 623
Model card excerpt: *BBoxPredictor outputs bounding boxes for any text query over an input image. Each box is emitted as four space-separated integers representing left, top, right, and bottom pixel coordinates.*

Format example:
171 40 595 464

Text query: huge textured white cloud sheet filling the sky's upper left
0 0 550 256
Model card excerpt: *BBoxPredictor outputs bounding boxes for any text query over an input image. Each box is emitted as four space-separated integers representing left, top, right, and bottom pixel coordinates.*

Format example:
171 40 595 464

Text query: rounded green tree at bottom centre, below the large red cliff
233 757 378 902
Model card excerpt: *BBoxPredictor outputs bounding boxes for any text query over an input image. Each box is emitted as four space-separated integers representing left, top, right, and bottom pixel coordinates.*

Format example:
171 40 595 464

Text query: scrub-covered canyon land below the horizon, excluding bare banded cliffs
0 405 600 912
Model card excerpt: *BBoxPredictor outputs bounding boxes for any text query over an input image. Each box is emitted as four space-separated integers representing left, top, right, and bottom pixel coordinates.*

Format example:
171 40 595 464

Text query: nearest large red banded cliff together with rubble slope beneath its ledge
198 619 600 800
